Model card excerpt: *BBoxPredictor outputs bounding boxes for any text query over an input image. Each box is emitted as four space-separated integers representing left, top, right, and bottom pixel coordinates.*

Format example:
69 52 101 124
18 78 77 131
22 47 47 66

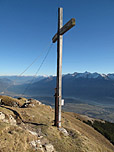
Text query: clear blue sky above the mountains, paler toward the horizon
0 0 114 75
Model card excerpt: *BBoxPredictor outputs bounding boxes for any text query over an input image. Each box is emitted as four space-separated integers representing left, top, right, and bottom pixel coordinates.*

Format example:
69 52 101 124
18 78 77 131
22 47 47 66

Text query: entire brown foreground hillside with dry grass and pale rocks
0 96 114 152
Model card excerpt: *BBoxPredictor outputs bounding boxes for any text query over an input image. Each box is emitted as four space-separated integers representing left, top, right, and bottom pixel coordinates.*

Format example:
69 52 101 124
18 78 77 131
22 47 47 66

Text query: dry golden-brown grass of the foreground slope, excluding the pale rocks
0 95 114 152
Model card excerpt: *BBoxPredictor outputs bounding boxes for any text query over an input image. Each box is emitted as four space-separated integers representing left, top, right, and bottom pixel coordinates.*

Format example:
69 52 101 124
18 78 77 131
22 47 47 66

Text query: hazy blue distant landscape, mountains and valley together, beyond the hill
0 72 114 122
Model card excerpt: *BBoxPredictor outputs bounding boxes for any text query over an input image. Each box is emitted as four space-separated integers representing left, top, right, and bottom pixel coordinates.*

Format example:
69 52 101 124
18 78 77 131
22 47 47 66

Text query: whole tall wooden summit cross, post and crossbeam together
52 8 75 128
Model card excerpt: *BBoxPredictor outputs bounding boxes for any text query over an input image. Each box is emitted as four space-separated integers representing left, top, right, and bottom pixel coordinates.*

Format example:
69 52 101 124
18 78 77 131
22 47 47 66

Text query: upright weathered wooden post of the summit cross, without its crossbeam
55 8 63 128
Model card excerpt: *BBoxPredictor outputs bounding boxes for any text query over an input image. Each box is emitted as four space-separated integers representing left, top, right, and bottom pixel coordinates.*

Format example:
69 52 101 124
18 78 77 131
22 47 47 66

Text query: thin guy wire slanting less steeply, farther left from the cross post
0 41 51 94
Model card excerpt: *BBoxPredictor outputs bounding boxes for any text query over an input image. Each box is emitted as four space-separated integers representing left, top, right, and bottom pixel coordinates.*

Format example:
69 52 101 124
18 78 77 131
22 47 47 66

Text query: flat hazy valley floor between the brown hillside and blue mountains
33 96 114 123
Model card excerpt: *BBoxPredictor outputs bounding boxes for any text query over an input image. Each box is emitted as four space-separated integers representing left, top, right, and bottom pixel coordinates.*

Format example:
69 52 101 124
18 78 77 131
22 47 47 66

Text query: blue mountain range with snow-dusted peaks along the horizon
0 72 114 102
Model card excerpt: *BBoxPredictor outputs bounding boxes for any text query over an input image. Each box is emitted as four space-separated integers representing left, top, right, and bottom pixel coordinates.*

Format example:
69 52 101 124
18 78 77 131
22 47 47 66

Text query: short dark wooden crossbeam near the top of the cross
52 18 75 43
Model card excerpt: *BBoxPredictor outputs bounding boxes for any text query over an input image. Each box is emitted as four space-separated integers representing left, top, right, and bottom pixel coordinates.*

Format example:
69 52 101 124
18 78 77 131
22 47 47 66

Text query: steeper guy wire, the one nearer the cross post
22 43 53 96
